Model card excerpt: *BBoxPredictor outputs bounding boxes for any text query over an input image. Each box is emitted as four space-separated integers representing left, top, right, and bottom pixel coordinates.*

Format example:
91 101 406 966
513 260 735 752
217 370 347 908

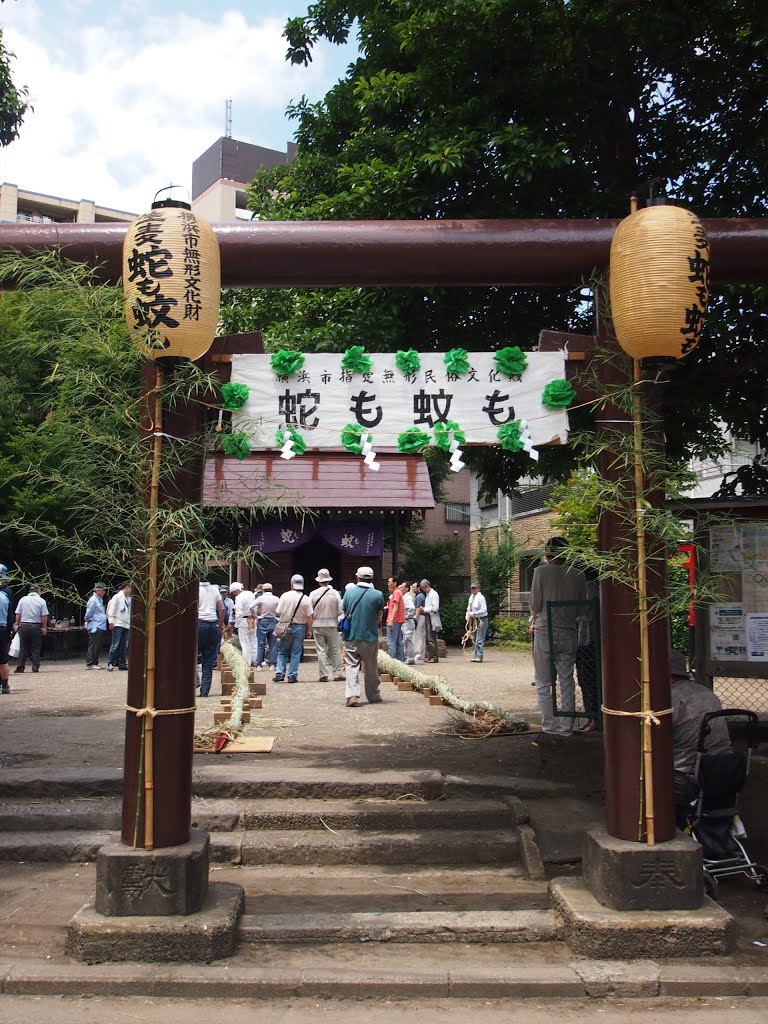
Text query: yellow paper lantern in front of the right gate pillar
610 206 710 359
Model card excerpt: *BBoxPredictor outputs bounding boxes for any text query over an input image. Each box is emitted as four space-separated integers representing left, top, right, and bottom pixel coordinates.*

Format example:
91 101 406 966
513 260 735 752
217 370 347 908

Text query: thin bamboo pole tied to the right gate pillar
632 359 655 846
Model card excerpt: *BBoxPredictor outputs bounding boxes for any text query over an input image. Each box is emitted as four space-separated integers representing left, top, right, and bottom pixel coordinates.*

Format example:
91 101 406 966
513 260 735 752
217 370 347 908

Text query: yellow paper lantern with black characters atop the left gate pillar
123 200 221 359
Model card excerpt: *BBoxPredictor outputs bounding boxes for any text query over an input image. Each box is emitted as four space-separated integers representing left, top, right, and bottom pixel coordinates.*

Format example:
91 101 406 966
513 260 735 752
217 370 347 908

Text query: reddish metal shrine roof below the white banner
203 452 434 511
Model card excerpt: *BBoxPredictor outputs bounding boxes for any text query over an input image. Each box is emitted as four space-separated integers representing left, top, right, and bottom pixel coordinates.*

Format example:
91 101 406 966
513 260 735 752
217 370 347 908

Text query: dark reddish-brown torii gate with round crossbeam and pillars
0 219 768 937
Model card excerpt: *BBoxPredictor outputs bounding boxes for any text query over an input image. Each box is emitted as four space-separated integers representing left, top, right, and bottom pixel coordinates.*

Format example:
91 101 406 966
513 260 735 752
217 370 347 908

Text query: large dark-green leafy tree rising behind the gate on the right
224 0 768 490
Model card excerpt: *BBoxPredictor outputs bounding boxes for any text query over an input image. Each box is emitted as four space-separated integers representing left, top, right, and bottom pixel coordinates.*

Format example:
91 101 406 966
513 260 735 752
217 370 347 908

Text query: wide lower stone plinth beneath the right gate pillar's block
550 879 736 961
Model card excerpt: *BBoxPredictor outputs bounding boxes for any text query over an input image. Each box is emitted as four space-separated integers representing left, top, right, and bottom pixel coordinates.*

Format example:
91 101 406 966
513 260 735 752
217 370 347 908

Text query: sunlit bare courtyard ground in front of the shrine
0 638 548 769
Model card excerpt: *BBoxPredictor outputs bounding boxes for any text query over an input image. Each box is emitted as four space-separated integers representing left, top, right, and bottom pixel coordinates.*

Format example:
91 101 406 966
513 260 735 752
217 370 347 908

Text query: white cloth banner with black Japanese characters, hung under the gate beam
231 352 568 449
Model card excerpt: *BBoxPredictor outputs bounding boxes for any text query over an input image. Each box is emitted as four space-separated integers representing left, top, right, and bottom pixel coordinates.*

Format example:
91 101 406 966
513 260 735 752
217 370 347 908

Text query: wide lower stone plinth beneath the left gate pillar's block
66 882 245 964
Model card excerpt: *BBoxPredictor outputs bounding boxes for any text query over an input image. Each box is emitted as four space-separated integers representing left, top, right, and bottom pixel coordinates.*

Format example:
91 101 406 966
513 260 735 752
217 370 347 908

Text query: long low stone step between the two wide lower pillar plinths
240 910 559 945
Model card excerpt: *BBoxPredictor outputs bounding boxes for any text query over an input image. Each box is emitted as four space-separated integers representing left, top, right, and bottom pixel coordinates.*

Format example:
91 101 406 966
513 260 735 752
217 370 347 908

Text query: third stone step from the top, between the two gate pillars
234 828 520 865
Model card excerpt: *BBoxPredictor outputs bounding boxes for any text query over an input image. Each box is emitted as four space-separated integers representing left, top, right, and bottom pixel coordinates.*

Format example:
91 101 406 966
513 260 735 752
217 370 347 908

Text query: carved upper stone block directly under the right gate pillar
582 827 703 910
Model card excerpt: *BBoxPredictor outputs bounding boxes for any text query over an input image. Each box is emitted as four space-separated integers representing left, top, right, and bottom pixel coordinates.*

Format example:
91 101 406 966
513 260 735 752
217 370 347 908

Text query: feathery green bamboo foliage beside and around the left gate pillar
0 252 270 601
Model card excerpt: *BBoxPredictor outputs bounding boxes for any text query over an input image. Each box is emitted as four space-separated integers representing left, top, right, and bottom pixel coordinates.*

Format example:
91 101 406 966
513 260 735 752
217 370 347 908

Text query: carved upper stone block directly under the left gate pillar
95 831 210 918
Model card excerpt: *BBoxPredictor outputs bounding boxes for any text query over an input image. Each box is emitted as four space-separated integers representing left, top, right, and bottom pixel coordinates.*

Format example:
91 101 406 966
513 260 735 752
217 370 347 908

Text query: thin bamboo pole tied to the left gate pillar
143 362 163 850
